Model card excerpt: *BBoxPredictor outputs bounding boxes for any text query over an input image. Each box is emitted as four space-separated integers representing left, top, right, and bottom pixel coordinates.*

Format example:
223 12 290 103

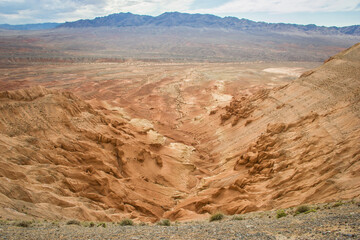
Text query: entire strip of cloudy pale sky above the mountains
0 0 360 26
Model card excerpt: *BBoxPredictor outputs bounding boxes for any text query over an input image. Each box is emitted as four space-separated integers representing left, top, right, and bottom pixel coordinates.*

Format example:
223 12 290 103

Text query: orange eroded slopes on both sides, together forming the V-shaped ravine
0 44 360 221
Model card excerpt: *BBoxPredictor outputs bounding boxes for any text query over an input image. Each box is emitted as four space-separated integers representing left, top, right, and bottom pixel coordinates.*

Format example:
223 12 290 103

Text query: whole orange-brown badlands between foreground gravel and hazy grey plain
0 40 360 226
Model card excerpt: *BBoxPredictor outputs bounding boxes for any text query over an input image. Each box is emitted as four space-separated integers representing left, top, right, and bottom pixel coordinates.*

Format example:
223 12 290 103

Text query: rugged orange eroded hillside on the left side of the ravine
0 87 208 221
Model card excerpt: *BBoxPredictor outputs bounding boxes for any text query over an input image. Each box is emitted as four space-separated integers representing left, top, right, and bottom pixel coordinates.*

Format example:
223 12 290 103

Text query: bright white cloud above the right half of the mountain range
192 0 359 14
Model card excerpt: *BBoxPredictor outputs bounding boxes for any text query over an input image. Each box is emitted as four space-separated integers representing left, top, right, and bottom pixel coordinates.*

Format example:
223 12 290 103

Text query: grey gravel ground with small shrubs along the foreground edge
0 202 360 240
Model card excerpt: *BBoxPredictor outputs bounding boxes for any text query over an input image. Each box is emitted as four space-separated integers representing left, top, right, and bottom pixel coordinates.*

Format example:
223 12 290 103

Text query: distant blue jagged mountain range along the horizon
57 12 360 36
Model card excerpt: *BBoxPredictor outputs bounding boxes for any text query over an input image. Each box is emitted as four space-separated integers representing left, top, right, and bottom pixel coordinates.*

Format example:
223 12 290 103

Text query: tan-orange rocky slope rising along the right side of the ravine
167 44 360 219
